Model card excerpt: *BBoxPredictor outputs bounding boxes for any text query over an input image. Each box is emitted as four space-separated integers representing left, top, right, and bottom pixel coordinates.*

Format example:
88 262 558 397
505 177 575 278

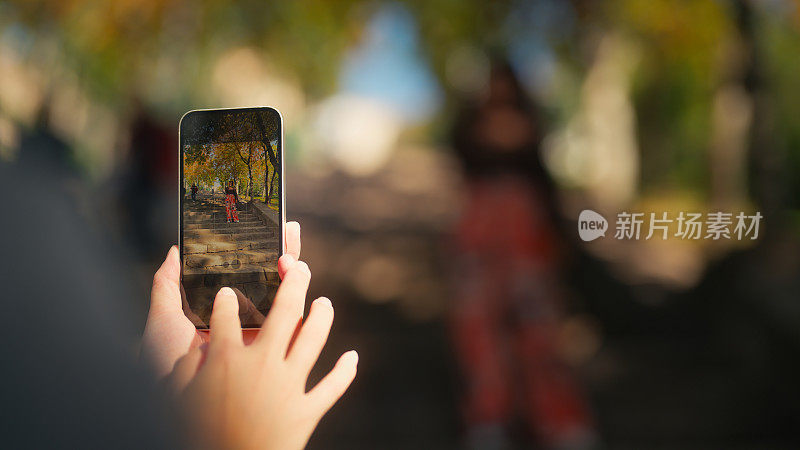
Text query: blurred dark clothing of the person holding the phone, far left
0 136 181 449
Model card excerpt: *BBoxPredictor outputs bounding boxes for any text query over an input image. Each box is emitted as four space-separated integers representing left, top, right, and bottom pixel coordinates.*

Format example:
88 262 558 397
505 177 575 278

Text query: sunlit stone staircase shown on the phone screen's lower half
182 198 279 323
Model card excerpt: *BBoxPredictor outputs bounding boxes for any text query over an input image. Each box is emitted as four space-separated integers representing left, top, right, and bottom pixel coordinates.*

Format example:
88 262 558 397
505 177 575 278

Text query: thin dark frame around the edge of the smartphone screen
178 106 286 331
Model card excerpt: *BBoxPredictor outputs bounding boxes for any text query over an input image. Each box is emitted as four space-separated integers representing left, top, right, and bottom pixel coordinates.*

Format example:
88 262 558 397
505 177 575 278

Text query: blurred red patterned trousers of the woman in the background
450 179 592 443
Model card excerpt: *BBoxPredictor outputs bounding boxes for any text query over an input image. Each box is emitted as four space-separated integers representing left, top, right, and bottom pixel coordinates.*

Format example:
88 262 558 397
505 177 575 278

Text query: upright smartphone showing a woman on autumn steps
178 107 286 329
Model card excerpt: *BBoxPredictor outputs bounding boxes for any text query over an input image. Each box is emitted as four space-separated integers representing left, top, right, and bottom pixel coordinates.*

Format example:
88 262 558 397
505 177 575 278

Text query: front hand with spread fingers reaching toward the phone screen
170 255 358 450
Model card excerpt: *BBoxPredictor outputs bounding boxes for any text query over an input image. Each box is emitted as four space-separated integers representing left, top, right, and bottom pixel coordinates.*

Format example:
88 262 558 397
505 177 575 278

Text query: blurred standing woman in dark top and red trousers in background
450 61 595 448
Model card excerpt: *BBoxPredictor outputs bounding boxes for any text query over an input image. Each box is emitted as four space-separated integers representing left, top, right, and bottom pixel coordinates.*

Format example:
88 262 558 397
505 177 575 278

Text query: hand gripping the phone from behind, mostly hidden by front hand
141 222 300 378
